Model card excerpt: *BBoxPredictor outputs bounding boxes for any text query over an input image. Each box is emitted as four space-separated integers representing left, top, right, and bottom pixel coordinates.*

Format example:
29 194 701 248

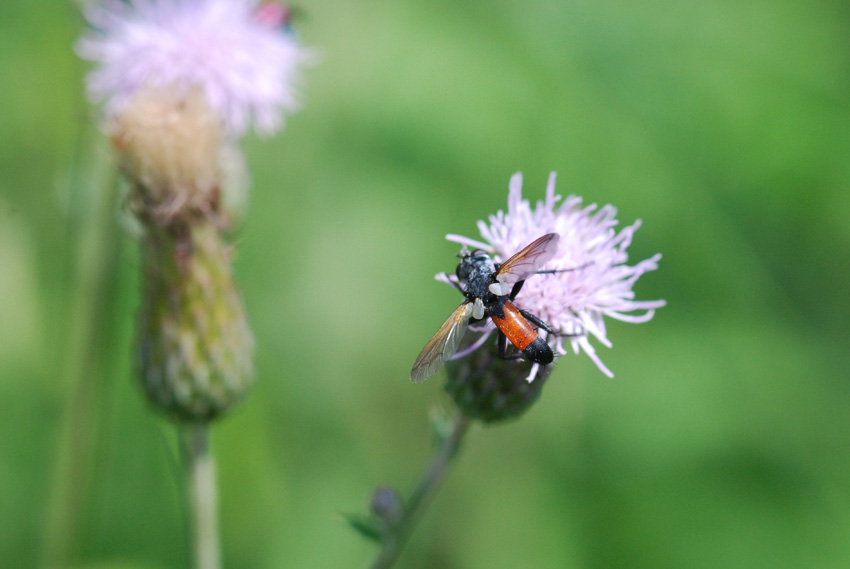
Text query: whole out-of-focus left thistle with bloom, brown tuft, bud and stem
70 0 309 569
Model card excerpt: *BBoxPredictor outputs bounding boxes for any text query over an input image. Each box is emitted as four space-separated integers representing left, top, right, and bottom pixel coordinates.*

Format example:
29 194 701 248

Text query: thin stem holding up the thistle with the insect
372 413 469 569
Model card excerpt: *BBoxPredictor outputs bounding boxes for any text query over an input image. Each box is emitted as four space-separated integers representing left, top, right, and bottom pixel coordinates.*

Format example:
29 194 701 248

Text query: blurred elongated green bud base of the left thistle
140 220 254 421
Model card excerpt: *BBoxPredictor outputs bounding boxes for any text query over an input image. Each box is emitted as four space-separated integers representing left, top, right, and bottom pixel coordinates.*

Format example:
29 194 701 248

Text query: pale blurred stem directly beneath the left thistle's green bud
179 423 221 569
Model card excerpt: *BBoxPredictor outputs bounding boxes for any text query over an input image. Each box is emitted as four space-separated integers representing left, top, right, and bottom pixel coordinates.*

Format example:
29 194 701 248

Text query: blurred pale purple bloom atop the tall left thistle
77 0 310 137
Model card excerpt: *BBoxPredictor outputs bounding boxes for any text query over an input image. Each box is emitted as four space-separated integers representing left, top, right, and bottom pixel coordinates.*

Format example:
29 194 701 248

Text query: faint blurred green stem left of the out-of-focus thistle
39 132 121 567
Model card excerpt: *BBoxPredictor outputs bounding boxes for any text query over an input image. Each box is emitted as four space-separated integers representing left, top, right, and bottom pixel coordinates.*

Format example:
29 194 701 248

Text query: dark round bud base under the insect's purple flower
445 348 552 423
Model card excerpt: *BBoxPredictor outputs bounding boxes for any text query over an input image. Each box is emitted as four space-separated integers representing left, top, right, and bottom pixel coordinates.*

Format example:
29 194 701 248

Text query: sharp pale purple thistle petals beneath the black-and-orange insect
437 172 665 381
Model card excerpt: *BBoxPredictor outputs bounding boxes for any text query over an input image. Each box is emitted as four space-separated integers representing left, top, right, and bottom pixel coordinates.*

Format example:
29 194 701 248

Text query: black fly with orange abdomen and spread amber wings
410 233 572 382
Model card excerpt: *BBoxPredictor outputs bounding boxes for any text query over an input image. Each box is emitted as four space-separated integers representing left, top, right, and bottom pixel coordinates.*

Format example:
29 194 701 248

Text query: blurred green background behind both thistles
0 0 850 569
